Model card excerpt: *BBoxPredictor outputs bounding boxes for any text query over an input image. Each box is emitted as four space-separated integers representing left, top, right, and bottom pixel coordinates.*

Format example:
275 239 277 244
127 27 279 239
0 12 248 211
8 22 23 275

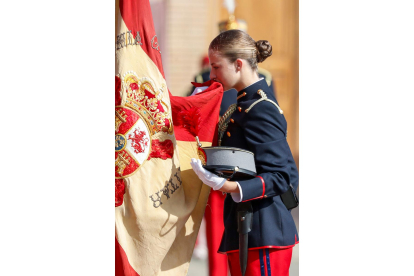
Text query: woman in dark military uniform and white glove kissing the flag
191 30 299 276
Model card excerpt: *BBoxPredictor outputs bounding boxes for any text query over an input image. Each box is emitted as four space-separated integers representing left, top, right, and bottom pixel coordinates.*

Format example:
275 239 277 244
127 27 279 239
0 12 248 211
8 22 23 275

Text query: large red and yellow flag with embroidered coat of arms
115 0 223 276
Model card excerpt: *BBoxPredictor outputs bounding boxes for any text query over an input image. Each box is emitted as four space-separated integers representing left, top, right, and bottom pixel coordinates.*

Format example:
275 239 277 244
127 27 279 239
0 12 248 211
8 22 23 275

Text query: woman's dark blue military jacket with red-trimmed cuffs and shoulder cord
219 79 299 252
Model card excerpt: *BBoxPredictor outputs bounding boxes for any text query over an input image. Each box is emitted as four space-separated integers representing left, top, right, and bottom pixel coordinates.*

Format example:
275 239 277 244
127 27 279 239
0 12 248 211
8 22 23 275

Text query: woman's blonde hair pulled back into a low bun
209 30 272 70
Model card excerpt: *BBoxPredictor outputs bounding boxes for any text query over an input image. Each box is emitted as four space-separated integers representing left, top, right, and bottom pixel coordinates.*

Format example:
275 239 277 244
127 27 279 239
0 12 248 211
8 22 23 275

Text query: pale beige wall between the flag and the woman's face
164 0 220 96
